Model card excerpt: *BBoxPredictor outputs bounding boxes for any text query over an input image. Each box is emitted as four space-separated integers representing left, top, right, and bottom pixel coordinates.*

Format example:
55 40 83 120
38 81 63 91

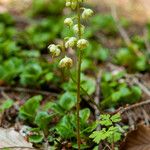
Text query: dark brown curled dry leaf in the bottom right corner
120 125 150 150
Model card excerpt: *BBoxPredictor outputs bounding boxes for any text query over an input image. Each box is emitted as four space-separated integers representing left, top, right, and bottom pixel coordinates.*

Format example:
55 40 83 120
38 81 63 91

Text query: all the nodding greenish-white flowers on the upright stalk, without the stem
48 0 93 68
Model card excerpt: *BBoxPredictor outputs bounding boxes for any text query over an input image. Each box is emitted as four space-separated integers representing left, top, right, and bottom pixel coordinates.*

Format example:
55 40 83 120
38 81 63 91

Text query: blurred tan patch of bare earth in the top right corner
90 0 150 22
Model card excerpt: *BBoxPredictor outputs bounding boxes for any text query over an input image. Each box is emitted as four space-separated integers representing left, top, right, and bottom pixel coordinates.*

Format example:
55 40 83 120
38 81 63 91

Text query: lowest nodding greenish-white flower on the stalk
59 56 73 68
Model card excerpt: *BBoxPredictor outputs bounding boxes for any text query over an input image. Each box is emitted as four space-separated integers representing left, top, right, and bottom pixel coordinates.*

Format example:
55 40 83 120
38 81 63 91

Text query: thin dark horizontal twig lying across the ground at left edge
0 86 57 96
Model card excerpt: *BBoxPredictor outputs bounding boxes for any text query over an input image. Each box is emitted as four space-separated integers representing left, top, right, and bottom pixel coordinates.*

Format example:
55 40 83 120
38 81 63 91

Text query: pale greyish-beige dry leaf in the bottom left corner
0 128 32 150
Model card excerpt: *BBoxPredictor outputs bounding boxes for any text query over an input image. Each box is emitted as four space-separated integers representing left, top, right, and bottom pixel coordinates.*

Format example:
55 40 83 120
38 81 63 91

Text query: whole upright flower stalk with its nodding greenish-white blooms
48 0 93 150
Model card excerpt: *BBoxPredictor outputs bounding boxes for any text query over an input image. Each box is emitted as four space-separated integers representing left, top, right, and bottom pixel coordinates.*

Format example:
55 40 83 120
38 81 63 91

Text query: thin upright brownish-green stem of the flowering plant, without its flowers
76 0 82 150
